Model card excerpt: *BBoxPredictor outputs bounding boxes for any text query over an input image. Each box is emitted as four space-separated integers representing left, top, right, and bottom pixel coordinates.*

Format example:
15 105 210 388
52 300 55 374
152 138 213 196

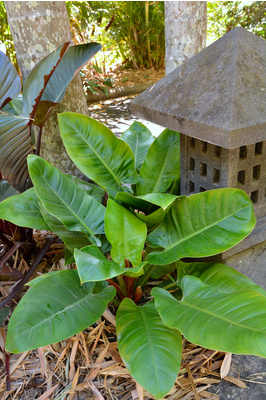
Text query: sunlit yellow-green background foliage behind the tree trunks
0 1 266 73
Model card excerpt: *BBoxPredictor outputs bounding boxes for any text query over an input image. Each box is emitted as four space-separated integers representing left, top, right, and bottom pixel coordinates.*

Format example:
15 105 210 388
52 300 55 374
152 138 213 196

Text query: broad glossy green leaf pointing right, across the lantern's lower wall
147 188 256 265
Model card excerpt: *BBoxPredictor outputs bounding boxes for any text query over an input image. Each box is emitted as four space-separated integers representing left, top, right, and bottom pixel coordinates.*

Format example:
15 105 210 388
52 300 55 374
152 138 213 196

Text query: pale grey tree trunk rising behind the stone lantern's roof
164 1 207 74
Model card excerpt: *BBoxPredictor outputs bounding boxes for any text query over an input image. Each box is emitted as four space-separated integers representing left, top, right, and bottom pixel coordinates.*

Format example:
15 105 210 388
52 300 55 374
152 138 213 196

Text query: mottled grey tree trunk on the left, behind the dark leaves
5 1 88 177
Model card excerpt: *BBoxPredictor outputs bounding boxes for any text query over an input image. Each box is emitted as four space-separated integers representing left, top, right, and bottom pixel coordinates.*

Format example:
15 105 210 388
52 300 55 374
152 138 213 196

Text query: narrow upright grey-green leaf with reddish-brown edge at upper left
21 42 70 118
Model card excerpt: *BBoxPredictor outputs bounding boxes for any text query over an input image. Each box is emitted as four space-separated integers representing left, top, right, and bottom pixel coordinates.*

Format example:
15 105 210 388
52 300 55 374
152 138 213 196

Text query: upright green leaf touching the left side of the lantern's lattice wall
137 129 180 196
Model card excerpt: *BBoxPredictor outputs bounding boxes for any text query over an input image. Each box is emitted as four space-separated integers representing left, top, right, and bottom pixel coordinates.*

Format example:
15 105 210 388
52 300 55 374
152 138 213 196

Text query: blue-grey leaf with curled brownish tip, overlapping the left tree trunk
40 42 102 105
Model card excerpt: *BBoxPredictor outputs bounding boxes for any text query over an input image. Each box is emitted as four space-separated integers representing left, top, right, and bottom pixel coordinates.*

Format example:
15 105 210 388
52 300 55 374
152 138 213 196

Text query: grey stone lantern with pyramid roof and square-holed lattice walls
131 27 266 288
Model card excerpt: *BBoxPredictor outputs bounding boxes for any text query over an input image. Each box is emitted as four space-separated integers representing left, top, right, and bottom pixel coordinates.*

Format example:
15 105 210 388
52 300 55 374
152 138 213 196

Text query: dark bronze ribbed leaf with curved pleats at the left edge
0 112 32 192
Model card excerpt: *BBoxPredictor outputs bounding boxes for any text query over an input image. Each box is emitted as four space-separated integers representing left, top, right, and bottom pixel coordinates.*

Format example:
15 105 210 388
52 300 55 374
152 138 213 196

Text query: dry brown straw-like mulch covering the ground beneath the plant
0 232 249 400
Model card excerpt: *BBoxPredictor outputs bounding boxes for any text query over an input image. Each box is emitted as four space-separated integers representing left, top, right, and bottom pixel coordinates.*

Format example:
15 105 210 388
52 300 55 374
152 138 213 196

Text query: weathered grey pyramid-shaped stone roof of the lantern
131 27 266 148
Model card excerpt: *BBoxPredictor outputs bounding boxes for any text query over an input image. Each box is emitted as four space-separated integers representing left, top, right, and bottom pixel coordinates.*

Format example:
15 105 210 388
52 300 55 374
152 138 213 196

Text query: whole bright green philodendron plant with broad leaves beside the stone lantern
0 113 266 399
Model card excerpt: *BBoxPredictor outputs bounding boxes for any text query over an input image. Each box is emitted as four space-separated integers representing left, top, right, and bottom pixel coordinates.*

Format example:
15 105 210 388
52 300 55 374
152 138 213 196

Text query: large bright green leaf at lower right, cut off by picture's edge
152 275 266 357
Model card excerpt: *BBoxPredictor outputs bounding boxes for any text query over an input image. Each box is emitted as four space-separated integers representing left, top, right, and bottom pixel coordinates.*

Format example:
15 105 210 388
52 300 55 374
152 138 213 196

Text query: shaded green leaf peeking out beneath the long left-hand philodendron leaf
39 201 91 255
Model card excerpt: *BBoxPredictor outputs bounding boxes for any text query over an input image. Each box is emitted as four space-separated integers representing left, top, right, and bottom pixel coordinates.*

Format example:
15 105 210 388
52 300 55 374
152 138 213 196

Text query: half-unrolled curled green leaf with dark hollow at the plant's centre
115 192 177 212
